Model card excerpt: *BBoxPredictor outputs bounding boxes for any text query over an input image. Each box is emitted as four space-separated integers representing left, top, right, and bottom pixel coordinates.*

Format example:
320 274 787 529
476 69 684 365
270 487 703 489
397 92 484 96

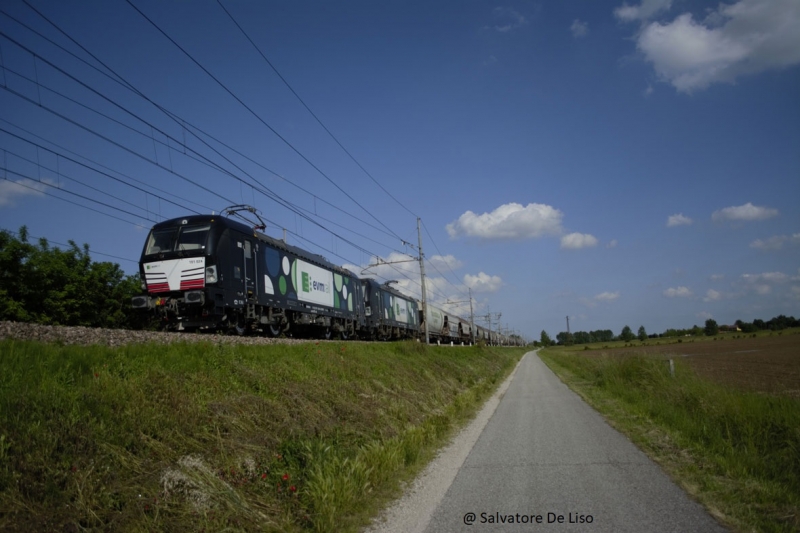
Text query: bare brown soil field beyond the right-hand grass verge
584 330 800 397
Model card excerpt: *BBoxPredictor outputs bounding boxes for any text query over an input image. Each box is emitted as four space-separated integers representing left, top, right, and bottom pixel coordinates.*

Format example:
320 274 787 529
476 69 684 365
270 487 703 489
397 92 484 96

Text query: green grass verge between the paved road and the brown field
539 346 800 532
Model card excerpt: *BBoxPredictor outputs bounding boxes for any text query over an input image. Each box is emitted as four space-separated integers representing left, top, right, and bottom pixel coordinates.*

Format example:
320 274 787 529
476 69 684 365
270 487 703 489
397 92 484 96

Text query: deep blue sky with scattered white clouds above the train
0 0 800 339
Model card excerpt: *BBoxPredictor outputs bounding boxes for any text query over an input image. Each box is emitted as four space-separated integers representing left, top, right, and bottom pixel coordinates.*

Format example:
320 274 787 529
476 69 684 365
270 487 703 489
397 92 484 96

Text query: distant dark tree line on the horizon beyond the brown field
534 315 800 346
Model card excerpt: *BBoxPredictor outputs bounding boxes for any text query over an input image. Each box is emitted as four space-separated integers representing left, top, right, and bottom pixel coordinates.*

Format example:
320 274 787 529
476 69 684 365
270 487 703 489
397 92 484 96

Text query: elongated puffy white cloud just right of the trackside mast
446 203 564 240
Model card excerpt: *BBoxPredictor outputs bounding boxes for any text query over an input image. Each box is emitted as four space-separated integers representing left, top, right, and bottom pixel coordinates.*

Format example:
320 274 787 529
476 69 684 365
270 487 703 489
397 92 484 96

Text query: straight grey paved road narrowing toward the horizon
418 353 725 533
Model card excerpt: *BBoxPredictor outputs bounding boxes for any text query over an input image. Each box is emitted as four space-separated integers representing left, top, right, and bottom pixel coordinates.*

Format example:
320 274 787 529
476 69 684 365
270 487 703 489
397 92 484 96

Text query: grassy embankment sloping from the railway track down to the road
0 340 525 532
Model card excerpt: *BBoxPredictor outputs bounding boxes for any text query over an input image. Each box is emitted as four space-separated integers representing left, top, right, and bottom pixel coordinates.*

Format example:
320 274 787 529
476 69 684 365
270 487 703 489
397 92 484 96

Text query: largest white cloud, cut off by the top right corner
632 0 800 93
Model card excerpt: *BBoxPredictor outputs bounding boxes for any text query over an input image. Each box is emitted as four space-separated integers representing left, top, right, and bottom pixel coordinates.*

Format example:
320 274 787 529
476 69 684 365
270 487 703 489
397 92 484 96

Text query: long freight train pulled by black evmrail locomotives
131 212 516 345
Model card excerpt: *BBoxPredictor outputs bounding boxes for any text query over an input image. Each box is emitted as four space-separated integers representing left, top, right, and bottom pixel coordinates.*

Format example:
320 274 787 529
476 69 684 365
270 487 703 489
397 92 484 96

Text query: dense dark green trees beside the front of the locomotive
0 226 143 328
